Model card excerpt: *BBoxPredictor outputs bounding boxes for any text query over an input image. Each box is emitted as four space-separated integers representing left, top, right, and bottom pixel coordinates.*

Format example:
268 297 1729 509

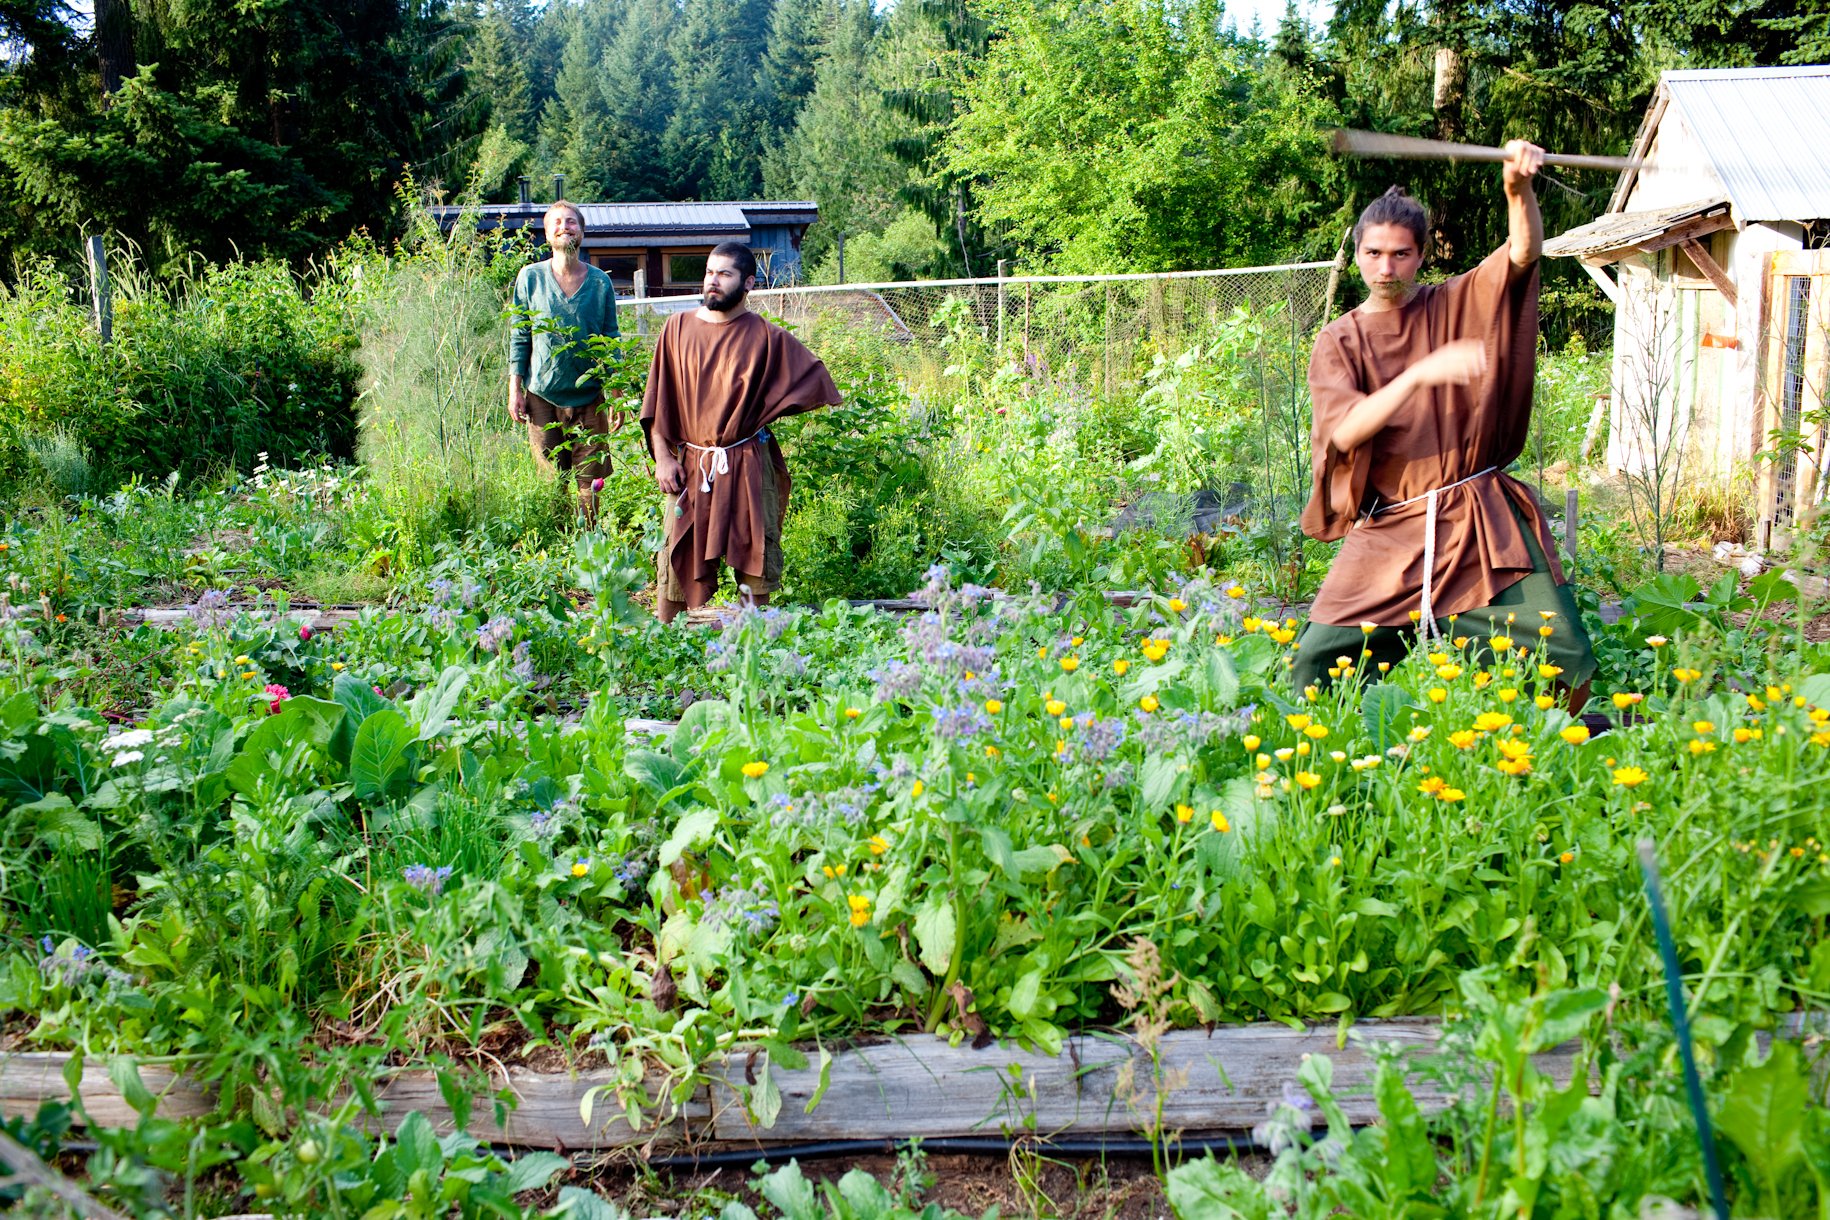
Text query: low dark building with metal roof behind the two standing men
432 176 820 296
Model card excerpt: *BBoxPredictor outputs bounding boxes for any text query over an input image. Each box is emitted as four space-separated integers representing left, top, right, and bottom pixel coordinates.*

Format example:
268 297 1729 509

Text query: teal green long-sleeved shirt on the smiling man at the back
509 260 617 406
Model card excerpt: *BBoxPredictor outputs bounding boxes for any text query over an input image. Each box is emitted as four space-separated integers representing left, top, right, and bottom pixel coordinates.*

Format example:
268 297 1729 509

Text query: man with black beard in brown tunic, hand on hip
642 241 840 622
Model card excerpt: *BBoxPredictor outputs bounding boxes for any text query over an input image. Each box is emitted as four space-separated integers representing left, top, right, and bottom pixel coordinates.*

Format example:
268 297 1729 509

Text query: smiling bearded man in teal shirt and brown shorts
509 199 626 523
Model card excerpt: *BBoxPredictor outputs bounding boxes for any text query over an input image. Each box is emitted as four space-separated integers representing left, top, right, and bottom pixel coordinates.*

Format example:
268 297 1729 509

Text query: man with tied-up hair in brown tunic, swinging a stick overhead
1294 141 1594 688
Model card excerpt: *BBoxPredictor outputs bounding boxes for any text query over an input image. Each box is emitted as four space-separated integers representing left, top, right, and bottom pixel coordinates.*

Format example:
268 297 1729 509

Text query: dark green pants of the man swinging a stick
1290 515 1596 690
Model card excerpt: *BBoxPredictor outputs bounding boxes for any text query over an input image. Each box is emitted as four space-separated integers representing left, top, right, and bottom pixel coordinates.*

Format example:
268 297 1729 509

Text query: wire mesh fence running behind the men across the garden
622 263 1332 397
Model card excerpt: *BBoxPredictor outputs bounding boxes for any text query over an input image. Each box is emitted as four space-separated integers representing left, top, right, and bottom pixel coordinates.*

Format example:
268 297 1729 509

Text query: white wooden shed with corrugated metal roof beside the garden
1545 66 1830 545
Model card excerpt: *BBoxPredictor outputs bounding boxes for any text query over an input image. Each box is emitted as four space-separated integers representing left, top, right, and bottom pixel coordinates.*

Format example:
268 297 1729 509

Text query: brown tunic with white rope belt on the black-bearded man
642 313 840 599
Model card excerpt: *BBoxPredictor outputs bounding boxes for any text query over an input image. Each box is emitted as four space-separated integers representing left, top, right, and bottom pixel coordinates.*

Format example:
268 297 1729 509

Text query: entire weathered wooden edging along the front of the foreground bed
0 1021 1576 1150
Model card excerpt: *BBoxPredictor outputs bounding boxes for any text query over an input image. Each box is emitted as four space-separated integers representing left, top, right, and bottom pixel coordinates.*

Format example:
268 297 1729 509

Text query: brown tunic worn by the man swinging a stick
1303 245 1563 627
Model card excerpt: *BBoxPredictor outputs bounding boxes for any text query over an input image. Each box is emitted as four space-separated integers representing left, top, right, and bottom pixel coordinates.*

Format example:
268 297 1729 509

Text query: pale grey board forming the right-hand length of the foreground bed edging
712 1021 1572 1141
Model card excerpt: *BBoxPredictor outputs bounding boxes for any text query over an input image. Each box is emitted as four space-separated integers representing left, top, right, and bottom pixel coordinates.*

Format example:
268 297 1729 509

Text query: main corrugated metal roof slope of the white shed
1658 66 1830 223
